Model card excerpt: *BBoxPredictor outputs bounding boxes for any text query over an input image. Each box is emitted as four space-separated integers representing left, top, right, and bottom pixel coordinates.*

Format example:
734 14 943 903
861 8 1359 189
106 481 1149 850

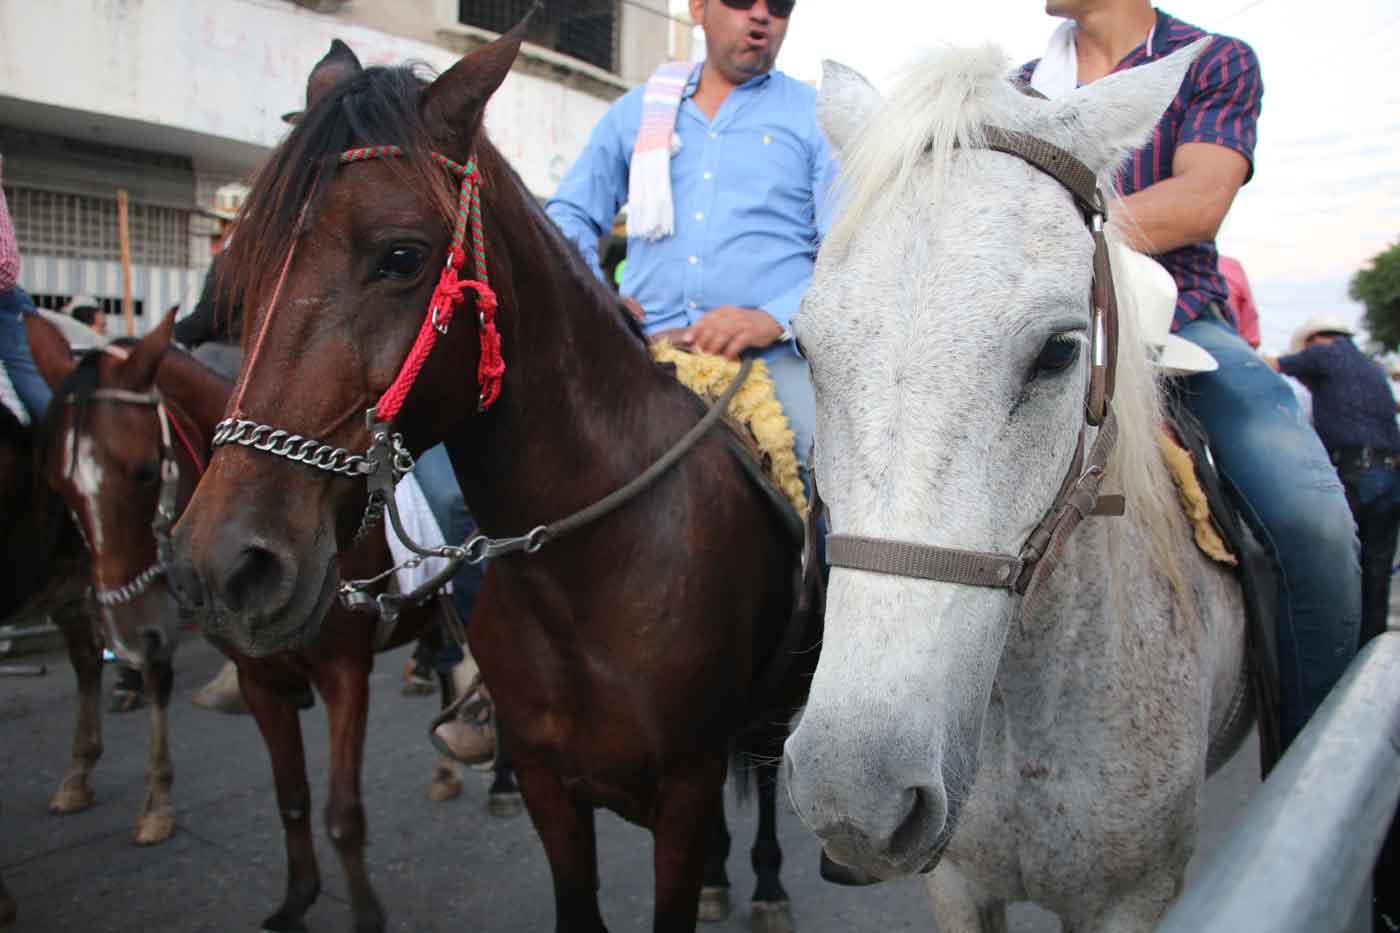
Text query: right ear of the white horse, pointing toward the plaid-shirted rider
1050 36 1212 175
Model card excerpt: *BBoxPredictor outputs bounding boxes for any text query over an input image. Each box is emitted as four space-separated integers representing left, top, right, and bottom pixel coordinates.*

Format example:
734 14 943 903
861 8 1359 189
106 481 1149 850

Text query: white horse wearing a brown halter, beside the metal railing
787 43 1249 933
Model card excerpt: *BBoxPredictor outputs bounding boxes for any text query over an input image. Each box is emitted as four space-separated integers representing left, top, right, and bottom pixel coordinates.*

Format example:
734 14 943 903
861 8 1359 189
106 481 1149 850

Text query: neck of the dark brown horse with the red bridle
448 157 694 534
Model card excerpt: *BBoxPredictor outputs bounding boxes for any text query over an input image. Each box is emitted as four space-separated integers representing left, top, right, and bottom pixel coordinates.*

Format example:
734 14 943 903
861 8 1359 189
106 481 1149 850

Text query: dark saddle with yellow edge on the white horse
1163 384 1281 776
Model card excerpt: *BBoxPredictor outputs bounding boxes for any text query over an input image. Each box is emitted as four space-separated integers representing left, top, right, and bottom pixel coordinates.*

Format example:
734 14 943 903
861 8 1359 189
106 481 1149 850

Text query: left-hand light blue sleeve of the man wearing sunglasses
545 88 641 280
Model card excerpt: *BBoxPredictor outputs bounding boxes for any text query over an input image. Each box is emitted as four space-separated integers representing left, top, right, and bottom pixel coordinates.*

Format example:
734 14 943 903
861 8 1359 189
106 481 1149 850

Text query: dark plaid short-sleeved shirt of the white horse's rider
1021 10 1264 331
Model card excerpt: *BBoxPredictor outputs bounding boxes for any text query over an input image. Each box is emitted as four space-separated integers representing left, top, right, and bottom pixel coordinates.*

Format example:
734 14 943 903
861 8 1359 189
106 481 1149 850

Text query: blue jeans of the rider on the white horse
1177 319 1361 747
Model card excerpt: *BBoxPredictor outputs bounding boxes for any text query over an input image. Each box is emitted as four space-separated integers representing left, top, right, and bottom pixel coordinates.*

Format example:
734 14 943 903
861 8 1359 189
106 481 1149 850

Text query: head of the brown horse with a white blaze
39 314 195 668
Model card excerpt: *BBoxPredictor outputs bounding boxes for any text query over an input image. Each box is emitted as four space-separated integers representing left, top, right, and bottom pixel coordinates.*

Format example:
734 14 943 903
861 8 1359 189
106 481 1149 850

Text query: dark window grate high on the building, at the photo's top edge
458 0 622 73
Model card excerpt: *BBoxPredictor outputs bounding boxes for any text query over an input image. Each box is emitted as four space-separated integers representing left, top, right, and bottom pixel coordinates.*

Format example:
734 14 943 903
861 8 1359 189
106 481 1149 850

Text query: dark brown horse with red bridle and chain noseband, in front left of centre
174 25 820 932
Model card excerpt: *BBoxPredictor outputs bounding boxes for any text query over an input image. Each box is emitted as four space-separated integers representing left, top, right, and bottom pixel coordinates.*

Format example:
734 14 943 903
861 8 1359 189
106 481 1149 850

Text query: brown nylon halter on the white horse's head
826 127 1123 612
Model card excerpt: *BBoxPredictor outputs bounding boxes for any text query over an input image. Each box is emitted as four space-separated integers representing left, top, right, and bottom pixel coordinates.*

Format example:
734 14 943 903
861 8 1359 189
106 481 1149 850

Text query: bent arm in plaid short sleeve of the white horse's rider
1110 38 1264 255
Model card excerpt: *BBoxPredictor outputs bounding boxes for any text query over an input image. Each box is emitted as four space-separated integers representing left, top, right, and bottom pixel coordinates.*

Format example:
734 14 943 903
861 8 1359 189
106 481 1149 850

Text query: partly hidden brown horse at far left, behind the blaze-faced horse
0 315 175 845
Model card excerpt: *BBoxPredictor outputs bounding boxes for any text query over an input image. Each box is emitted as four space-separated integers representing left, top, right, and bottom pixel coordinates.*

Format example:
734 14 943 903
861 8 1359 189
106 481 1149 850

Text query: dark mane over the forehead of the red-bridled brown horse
218 64 455 323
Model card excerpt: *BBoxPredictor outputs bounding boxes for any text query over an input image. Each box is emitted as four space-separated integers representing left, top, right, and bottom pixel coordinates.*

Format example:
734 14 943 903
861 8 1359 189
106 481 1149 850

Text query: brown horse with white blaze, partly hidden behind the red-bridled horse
45 317 518 930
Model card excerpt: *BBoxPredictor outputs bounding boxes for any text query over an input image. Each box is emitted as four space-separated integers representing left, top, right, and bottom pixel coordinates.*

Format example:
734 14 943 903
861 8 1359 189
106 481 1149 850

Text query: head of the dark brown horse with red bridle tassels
175 29 522 656
